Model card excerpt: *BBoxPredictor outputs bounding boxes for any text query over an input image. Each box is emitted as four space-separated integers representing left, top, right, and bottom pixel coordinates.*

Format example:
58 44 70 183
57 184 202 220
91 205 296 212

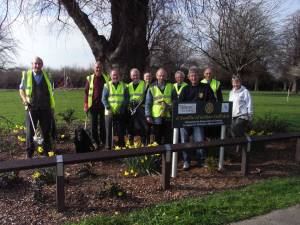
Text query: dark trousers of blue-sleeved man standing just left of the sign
152 119 173 145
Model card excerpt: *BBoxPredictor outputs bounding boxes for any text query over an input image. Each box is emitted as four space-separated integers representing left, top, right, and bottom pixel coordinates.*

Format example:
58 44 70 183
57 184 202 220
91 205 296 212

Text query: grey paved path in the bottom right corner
231 205 300 225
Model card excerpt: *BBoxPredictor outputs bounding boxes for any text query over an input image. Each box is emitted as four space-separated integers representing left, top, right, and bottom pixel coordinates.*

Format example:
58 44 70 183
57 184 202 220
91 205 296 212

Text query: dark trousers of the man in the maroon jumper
89 107 106 145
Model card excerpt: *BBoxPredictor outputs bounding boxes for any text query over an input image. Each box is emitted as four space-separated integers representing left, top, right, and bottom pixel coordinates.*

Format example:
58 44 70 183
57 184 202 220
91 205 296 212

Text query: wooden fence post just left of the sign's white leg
161 144 172 190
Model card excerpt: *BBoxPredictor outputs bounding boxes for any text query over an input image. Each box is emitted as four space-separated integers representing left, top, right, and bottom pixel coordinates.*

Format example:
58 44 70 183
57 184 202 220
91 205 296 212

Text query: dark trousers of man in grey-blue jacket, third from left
105 114 125 149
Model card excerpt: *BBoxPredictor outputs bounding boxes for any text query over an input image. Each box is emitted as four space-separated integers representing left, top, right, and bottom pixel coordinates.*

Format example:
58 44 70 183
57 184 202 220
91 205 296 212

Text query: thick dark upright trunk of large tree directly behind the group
108 0 149 77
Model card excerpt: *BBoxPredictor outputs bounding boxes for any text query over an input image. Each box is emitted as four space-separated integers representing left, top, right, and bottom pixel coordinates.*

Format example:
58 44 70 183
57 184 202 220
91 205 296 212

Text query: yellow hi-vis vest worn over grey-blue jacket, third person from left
105 81 126 115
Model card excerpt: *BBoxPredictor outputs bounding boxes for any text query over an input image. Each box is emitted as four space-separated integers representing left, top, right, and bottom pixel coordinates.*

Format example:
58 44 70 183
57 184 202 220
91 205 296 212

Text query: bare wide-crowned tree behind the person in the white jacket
188 0 275 81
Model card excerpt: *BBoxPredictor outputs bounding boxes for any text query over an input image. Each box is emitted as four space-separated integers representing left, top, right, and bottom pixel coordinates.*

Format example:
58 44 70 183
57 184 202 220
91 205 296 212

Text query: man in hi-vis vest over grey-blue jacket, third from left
102 68 128 149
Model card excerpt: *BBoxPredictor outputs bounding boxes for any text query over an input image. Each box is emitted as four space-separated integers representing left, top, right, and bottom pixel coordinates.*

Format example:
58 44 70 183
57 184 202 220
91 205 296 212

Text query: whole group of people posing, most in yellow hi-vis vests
20 57 253 170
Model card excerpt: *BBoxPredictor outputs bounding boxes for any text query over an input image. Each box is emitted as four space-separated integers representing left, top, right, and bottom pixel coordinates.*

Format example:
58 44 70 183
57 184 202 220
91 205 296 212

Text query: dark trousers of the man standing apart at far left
25 109 53 157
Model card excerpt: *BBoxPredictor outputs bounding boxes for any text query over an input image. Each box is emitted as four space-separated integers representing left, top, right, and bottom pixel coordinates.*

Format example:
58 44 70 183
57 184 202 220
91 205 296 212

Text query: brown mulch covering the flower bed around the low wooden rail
0 141 300 225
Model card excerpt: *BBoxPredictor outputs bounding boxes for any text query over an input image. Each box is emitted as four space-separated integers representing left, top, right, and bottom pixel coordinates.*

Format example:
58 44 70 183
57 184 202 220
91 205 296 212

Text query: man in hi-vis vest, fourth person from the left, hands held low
127 68 148 144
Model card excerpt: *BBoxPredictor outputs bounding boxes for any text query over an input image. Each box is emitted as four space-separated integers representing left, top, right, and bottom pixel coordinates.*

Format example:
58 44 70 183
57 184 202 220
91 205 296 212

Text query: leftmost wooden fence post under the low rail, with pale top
56 155 65 212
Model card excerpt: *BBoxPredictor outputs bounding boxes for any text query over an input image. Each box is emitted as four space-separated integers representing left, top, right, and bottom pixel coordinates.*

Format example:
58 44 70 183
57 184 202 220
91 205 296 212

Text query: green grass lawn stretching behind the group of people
0 89 300 130
